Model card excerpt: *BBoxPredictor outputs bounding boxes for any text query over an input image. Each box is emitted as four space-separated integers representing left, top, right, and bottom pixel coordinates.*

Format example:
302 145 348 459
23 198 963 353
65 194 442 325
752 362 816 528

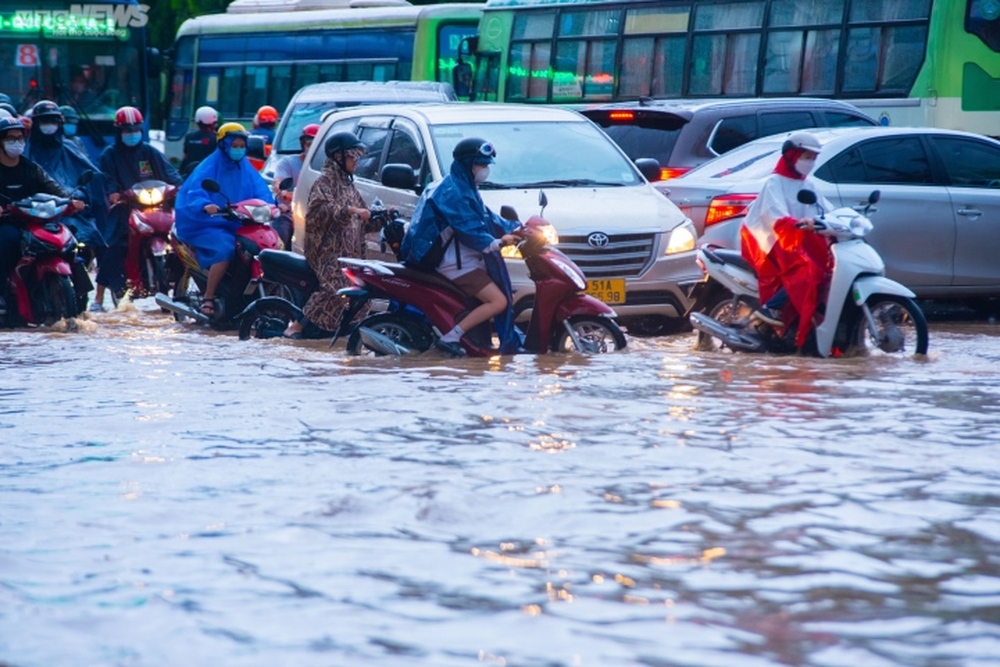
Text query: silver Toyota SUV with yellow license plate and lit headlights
292 103 701 333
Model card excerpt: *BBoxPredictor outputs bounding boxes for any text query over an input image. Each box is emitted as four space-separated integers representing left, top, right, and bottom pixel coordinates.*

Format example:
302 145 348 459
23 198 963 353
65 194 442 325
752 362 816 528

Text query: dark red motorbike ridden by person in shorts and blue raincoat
338 193 626 357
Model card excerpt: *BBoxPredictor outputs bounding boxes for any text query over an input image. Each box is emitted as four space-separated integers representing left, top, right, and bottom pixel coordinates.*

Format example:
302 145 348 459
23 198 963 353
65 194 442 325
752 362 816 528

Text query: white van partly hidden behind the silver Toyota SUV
261 81 458 182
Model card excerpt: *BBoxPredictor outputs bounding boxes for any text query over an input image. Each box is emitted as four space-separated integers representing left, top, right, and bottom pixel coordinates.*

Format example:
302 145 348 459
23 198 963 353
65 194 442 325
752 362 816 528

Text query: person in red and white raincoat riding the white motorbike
740 132 834 348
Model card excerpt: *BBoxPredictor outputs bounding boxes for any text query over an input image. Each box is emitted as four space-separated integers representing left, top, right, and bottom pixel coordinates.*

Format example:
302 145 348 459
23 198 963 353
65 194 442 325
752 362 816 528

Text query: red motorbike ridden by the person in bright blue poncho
155 179 281 330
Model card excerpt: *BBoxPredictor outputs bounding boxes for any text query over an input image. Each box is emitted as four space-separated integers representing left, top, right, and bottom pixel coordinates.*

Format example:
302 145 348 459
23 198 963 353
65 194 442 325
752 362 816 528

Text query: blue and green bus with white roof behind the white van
165 0 483 158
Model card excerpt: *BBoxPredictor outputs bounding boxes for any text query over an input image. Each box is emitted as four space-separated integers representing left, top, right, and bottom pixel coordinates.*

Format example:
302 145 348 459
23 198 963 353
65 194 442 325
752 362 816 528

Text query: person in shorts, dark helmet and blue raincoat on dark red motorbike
401 137 523 356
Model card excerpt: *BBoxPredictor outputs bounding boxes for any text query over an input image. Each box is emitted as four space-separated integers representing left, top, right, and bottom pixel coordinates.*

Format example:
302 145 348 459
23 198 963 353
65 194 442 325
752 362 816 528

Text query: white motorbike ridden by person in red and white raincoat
689 190 928 357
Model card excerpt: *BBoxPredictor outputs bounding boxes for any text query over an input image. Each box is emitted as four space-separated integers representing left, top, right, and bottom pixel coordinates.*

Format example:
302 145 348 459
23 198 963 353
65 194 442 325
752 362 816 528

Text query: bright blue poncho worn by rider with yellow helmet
174 141 274 268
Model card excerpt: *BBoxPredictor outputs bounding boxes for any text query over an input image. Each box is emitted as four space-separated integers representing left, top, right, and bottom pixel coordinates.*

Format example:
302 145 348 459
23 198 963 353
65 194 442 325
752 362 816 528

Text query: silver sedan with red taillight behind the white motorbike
658 128 1000 299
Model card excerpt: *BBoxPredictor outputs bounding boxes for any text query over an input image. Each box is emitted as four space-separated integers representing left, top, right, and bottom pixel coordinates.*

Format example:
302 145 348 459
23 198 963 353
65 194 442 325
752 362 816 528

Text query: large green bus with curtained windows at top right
466 0 1000 135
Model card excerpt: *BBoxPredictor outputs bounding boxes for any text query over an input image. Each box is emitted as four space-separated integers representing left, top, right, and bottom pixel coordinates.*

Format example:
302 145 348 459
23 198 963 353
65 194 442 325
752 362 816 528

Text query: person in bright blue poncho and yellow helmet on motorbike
174 123 274 317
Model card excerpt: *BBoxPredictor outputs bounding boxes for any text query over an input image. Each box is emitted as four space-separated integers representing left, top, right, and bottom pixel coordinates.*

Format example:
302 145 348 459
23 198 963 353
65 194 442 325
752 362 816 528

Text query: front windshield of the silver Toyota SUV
430 121 643 190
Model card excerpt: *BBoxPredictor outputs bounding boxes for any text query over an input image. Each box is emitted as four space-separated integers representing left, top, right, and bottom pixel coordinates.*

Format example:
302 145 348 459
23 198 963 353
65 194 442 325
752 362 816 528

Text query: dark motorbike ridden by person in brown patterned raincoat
238 198 406 345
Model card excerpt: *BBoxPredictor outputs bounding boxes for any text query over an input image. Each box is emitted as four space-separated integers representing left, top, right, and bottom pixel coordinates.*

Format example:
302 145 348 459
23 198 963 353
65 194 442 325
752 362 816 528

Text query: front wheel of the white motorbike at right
853 294 928 355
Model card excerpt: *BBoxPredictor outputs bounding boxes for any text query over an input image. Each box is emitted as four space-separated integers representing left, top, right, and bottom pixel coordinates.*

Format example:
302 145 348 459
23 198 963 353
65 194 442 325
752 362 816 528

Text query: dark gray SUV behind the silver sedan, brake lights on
580 97 877 180
